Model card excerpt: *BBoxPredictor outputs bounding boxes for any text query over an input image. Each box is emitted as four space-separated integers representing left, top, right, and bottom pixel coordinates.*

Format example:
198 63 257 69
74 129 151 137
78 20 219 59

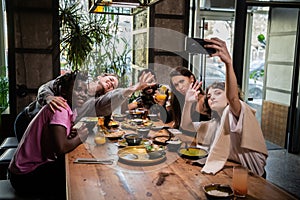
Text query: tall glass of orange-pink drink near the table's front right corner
232 166 248 197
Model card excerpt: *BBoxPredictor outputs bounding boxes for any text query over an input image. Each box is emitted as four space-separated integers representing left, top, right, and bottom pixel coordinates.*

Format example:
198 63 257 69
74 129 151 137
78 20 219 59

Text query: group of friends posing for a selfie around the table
9 38 268 199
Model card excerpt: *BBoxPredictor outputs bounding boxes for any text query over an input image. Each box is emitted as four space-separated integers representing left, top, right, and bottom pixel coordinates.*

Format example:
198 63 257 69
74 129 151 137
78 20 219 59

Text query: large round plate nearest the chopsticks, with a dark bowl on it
118 146 166 165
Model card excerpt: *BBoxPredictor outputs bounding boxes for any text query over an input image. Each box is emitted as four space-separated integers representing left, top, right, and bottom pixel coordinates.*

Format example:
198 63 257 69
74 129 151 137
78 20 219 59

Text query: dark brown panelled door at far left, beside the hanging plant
6 0 60 117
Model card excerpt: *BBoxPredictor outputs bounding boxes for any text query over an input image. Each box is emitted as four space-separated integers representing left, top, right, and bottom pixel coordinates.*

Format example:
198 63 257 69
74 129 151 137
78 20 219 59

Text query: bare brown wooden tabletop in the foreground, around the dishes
65 124 296 200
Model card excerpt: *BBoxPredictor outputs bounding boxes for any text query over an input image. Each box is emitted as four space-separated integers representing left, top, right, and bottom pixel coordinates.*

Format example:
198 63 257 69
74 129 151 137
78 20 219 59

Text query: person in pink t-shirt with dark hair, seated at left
9 72 88 199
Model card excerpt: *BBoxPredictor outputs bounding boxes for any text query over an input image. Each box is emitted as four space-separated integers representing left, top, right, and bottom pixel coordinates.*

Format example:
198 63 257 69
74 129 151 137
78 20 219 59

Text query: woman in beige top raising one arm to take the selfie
181 38 268 177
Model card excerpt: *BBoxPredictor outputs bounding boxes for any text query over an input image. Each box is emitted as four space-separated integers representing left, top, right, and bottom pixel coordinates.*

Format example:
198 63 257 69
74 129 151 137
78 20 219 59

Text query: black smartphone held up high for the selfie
185 37 216 54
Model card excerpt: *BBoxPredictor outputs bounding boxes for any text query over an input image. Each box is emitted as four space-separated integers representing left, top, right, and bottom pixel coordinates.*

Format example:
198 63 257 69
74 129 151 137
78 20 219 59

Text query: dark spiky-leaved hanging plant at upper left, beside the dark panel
59 2 110 70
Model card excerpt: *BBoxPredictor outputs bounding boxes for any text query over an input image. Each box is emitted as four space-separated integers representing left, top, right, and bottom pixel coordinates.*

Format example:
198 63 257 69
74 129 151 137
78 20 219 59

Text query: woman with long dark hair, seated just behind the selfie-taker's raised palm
170 67 210 133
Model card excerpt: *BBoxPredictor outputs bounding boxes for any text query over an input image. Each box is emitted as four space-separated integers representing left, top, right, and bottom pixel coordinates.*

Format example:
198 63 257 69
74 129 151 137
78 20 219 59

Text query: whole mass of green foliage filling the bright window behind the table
60 1 131 86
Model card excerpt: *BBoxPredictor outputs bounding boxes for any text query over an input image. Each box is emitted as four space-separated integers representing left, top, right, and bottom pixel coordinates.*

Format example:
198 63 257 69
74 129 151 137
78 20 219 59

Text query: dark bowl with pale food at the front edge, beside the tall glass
203 183 234 199
